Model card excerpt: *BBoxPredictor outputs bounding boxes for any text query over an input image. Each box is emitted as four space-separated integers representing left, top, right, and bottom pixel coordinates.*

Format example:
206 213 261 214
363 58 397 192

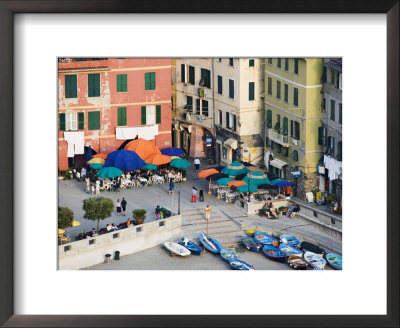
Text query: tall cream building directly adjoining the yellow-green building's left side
213 58 264 164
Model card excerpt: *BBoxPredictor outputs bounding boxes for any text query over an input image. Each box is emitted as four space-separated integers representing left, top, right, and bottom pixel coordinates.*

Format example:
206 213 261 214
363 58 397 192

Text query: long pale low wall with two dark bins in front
58 215 182 270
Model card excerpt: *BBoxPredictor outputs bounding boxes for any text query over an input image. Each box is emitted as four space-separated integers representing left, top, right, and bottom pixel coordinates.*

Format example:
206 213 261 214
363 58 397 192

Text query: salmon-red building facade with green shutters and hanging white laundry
58 58 172 170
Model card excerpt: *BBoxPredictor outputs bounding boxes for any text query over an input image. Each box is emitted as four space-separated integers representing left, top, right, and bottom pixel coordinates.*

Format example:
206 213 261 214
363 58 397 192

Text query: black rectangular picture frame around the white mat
0 0 400 327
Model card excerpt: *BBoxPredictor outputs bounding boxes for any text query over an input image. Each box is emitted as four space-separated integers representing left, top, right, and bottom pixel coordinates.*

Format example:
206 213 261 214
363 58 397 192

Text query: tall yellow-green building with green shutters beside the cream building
264 58 323 198
